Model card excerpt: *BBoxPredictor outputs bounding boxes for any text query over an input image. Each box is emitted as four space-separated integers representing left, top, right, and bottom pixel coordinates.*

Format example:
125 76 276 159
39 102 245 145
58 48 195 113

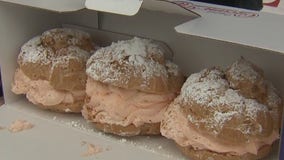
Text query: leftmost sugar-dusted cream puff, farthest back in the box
12 28 94 112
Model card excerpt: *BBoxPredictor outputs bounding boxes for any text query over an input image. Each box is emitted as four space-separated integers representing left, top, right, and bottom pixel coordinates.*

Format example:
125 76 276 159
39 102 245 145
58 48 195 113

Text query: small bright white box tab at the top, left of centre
85 0 143 16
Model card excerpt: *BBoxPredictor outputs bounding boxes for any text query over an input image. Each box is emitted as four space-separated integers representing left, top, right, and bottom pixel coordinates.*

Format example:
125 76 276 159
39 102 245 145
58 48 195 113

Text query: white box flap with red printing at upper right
166 0 284 53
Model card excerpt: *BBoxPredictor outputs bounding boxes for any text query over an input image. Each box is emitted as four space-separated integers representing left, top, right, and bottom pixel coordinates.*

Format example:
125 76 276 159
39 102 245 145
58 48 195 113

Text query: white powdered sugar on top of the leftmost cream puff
18 29 90 75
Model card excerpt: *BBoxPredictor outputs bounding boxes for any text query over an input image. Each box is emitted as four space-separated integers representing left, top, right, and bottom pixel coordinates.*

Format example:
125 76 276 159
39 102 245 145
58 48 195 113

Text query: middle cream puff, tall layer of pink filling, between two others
82 38 183 136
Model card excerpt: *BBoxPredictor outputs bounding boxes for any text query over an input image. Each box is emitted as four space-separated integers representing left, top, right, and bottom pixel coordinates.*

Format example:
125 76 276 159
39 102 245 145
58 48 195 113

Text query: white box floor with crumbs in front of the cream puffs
0 98 278 160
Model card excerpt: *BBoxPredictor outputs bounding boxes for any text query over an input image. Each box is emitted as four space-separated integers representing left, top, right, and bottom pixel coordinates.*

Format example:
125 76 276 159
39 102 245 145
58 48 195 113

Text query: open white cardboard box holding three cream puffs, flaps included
0 0 284 160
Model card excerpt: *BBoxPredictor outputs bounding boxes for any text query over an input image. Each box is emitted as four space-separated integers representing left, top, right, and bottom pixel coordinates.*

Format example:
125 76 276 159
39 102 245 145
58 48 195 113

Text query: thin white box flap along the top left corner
1 0 85 12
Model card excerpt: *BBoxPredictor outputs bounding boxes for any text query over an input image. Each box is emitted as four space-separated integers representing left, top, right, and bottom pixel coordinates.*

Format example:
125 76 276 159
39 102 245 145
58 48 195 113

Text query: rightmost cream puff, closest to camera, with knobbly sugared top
161 58 282 160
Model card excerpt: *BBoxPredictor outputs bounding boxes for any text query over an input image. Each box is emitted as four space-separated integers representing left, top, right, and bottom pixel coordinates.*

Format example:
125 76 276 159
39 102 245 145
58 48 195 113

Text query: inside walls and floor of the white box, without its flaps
0 2 284 160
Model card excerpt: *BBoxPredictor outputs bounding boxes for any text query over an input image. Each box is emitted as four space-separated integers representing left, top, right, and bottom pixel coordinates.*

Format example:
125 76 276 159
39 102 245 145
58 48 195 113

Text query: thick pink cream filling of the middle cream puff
86 78 175 127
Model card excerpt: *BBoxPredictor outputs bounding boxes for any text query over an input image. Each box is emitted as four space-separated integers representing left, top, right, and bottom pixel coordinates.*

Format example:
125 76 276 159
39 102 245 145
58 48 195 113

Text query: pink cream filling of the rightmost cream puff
161 105 279 155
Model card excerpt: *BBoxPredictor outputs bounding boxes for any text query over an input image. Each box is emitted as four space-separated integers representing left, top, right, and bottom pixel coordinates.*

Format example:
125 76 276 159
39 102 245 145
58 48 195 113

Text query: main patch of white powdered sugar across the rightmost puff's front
179 66 268 134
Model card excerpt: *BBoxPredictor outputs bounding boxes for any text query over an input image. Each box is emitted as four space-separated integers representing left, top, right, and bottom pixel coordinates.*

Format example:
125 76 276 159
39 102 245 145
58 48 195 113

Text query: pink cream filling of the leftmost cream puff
12 69 85 106
